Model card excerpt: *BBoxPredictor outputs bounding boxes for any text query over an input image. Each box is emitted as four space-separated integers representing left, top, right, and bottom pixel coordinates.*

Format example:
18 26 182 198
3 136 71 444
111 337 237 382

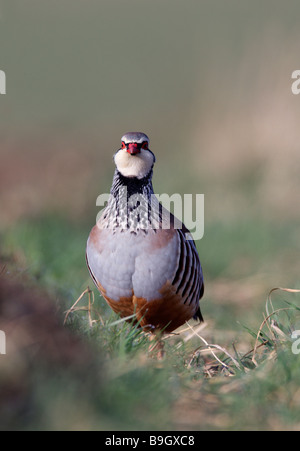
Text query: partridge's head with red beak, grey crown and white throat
114 132 155 179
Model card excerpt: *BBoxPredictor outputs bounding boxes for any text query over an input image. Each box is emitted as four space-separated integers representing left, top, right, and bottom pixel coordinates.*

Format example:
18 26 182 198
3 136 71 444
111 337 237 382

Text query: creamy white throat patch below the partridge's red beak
114 149 154 179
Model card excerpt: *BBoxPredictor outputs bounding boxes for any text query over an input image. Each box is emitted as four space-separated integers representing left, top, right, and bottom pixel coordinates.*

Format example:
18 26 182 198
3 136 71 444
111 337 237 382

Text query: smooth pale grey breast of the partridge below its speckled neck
87 226 180 301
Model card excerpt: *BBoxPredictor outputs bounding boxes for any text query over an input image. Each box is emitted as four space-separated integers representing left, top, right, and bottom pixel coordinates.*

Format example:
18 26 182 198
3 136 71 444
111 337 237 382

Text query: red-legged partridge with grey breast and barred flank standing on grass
86 132 204 334
